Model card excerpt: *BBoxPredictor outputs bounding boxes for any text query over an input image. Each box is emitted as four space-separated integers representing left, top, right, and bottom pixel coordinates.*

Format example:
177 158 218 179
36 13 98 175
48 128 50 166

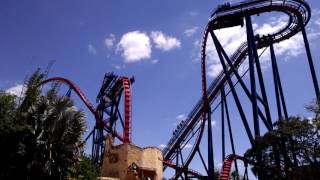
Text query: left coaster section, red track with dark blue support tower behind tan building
41 73 134 164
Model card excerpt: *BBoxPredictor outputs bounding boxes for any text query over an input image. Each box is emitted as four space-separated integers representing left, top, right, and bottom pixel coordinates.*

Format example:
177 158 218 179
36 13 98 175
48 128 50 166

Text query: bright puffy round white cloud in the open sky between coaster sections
116 31 151 63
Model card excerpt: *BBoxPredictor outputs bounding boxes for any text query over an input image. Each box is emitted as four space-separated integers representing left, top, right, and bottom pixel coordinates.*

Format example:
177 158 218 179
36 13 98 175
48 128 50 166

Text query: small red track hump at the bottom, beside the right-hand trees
219 154 249 180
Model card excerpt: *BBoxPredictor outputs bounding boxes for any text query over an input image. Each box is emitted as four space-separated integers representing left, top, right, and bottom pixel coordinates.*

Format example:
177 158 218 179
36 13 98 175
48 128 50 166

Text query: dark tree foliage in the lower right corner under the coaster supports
245 99 320 180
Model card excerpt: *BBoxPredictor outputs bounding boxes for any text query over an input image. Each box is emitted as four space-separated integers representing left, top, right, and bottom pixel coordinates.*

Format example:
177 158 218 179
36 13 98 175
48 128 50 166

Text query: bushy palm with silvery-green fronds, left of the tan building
28 89 85 179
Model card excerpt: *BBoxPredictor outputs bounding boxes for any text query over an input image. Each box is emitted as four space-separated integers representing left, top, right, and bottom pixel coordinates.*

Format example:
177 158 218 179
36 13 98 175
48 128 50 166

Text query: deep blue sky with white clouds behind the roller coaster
0 0 320 178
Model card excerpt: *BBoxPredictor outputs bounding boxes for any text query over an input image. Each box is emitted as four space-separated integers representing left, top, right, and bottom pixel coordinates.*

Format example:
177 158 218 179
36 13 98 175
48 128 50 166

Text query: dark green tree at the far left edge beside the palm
0 91 30 179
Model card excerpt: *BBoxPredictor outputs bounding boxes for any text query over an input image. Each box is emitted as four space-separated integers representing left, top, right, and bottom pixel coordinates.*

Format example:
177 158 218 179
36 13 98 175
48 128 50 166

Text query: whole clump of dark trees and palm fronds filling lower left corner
0 70 86 179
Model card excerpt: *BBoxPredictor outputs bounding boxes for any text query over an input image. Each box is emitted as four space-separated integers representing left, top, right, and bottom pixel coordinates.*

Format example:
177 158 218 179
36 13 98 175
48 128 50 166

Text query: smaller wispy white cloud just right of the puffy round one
150 31 181 51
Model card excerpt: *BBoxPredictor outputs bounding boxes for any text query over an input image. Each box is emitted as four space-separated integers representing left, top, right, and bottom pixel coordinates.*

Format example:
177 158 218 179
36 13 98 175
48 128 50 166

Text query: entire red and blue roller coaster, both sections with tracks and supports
42 0 319 180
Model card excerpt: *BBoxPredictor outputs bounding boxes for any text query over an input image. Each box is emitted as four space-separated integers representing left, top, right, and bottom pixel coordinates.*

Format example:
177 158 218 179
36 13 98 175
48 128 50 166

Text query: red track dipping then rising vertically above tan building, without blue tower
40 77 131 143
